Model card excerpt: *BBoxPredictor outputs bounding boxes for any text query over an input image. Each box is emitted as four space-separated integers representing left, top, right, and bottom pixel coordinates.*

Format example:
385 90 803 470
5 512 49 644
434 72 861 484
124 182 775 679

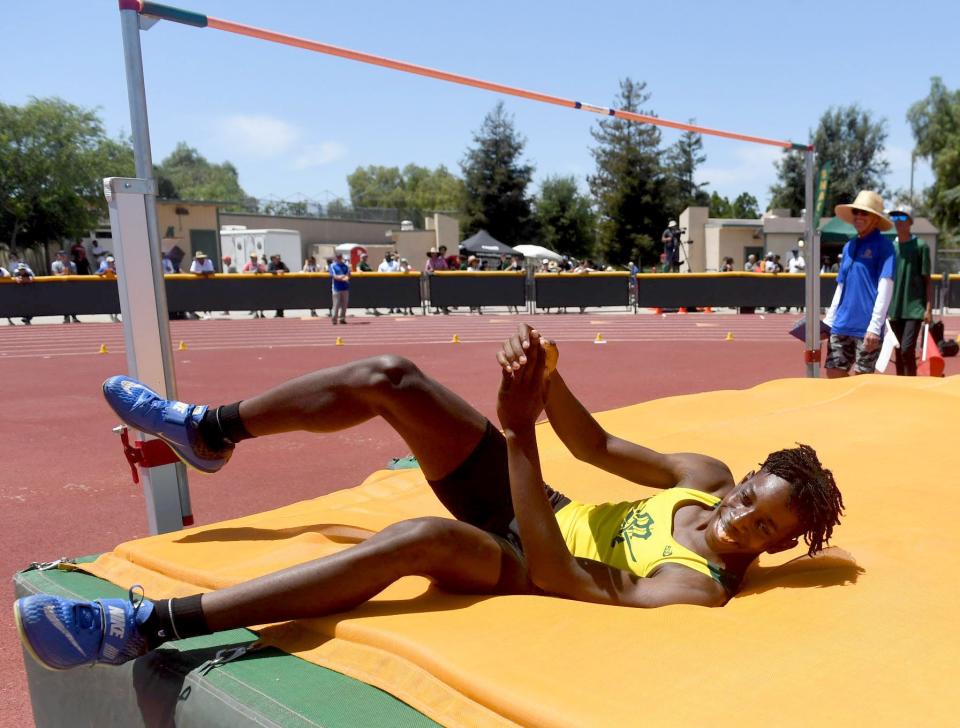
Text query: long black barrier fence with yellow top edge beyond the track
0 271 960 317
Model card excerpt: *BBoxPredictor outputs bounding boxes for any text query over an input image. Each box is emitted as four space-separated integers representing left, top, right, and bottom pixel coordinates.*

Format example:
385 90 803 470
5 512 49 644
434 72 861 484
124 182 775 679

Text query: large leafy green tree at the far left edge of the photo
0 98 133 248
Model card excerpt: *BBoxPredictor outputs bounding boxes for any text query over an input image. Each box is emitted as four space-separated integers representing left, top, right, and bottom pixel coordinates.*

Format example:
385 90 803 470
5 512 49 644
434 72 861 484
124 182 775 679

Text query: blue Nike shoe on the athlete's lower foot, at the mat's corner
13 587 153 670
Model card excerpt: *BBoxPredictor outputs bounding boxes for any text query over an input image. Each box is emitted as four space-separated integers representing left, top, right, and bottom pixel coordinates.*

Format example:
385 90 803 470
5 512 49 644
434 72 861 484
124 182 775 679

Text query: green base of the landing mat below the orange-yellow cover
14 557 437 728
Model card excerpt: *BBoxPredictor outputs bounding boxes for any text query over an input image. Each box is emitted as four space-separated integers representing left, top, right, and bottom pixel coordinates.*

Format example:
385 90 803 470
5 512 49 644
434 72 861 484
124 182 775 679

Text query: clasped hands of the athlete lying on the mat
497 324 559 430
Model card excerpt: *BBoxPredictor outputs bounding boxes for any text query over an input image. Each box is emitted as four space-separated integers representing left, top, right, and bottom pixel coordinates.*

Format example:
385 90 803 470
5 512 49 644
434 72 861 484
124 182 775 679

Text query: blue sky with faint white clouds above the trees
0 0 960 206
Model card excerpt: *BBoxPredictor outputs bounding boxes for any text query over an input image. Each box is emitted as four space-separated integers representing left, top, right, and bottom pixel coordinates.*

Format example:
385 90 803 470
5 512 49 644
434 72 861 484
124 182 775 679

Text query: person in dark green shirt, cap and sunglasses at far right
889 206 933 377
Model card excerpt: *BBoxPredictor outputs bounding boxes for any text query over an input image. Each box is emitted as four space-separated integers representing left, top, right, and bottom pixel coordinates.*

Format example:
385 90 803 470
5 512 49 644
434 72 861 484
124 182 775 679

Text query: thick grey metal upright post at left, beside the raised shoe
112 0 193 533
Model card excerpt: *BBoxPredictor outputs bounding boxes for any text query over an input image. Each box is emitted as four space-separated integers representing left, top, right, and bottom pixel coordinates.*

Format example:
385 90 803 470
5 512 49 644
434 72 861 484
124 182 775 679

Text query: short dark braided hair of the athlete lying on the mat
761 443 843 556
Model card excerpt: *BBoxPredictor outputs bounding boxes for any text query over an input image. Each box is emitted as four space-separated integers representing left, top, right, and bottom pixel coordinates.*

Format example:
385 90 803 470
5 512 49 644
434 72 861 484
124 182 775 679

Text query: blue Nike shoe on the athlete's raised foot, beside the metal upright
103 375 233 473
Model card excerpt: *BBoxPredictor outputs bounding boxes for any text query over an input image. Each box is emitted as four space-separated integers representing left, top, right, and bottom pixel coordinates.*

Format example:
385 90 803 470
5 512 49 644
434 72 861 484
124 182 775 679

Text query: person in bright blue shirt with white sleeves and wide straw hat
824 190 896 379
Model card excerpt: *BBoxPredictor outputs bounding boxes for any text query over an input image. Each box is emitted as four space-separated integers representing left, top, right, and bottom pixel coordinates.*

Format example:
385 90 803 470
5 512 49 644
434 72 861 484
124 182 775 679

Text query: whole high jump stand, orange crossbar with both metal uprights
104 0 820 533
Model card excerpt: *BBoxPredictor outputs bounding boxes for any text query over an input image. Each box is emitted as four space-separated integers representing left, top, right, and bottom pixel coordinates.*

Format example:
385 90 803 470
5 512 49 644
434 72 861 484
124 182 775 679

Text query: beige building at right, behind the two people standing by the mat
680 207 939 273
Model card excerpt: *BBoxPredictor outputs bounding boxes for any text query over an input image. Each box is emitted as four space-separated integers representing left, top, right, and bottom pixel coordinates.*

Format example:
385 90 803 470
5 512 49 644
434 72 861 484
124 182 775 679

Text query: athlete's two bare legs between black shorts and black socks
194 355 529 630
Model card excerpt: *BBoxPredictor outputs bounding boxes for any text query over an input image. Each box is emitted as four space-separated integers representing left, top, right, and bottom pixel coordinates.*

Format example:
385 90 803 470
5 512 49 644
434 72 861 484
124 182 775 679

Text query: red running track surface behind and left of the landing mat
0 314 960 726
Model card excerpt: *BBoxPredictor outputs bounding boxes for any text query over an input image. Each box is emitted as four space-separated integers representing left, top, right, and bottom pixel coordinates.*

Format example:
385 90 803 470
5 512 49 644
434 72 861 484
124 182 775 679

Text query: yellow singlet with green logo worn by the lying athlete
557 488 737 591
